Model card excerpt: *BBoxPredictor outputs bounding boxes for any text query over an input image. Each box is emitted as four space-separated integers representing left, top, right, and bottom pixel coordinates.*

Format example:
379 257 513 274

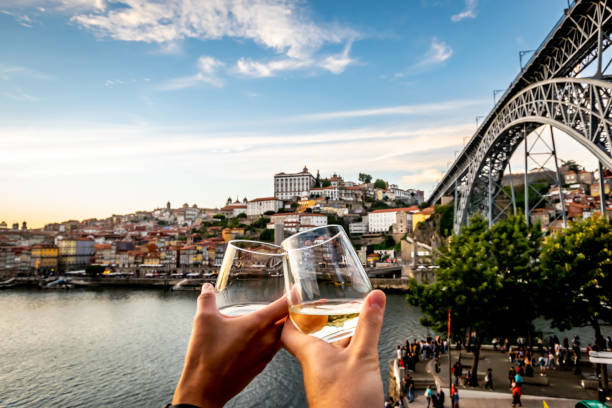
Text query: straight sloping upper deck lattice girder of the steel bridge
427 0 612 204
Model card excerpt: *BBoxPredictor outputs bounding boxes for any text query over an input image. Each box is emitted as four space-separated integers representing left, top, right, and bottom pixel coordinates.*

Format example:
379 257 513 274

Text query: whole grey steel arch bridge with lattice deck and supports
428 0 612 232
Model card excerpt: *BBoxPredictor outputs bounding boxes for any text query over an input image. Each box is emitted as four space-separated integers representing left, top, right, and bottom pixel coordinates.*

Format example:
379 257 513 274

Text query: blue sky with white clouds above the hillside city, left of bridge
0 0 584 226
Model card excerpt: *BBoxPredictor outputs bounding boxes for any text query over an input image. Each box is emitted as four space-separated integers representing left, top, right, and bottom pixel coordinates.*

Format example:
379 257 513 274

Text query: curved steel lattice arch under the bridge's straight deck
455 78 612 231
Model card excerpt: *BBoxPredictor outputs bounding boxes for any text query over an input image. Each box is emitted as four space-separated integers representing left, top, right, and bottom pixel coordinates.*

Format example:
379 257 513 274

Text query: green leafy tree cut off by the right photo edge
540 218 612 388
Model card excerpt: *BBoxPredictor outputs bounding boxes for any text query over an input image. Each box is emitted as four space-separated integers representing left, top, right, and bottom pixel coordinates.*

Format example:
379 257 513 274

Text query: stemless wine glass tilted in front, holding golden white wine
281 225 372 343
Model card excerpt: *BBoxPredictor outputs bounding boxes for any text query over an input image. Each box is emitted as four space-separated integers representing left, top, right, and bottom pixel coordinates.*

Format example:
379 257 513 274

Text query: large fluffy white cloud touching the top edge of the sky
72 0 355 59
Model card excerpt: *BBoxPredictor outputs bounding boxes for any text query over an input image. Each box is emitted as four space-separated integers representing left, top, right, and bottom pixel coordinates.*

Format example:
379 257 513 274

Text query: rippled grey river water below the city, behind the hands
0 290 604 408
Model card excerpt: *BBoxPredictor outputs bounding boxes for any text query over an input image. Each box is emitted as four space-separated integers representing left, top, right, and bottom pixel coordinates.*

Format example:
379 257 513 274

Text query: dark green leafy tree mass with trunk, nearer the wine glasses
407 216 543 385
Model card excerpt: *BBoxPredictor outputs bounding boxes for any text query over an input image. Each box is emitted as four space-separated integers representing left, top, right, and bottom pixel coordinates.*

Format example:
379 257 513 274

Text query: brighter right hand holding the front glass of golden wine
281 290 385 408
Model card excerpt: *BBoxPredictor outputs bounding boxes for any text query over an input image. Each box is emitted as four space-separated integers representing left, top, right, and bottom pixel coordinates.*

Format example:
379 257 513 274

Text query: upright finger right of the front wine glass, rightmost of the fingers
351 290 386 352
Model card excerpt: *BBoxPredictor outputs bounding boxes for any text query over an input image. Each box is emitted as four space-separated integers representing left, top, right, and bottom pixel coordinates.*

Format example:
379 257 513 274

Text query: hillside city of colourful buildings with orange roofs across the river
0 162 612 279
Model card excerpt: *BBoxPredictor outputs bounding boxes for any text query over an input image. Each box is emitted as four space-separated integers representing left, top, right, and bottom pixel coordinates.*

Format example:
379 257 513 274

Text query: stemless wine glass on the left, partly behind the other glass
216 240 285 316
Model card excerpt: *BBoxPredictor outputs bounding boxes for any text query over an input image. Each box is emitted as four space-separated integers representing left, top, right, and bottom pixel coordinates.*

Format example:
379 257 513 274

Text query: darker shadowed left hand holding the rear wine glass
172 283 288 408
